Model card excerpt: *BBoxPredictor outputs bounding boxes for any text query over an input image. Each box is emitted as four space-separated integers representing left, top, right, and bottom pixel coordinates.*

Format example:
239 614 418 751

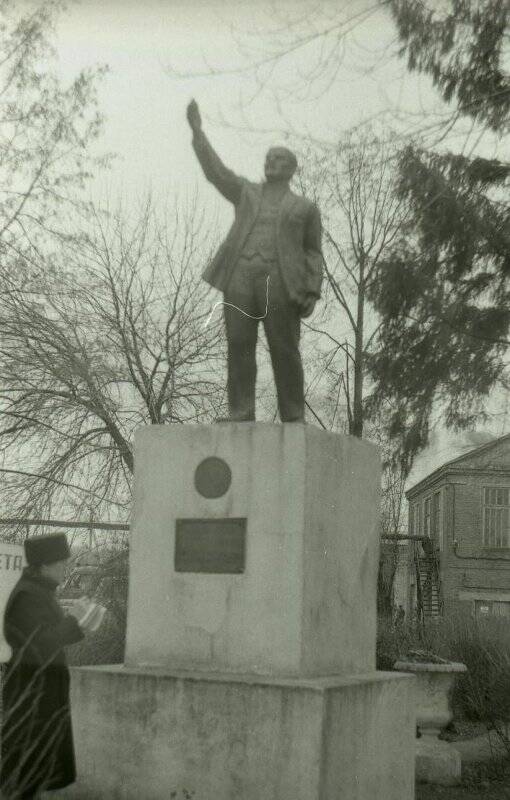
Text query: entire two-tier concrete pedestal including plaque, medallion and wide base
63 424 415 800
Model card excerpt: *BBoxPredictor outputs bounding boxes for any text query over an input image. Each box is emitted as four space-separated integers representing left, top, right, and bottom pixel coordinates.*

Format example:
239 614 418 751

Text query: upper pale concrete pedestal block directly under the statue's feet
126 423 380 675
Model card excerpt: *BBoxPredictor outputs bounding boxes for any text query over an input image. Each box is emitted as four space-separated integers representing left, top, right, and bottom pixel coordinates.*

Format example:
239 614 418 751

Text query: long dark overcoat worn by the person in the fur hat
1 567 83 800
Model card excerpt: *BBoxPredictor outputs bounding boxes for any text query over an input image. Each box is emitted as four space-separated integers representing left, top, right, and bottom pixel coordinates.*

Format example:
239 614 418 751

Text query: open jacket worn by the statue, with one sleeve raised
193 131 324 306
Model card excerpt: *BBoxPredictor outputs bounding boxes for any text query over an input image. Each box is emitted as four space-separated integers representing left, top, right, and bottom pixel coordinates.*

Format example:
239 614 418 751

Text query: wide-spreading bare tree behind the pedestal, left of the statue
0 201 222 519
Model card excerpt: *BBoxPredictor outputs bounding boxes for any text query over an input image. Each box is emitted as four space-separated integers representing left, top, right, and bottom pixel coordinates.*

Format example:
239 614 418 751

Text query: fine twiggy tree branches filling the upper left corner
0 0 105 269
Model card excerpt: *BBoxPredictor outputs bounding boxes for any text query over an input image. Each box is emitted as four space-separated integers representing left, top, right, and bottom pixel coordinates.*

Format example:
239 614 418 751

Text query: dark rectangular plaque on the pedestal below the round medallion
174 517 246 575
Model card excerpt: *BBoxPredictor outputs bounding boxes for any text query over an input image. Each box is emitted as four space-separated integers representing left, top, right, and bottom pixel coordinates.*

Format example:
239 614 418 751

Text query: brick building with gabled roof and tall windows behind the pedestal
406 434 510 617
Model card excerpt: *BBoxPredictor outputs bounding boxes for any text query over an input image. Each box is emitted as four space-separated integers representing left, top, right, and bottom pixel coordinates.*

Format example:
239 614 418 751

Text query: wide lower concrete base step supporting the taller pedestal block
62 667 415 800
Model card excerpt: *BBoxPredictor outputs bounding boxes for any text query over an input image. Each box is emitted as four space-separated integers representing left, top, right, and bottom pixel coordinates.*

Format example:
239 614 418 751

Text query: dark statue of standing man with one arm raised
187 100 323 422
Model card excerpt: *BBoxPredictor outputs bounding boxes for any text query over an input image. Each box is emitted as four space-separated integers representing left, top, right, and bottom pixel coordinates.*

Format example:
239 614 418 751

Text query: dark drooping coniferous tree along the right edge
370 0 510 467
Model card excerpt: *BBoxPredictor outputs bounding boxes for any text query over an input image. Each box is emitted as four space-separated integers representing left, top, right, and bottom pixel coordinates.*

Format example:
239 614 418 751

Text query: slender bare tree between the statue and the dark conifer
302 135 406 437
